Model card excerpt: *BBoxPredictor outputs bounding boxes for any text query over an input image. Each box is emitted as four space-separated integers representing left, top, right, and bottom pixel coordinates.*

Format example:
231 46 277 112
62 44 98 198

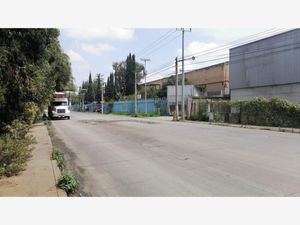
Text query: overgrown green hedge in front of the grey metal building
190 97 300 128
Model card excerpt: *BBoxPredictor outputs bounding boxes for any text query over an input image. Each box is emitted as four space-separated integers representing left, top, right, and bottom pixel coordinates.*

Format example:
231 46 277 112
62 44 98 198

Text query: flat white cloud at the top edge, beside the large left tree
64 28 134 40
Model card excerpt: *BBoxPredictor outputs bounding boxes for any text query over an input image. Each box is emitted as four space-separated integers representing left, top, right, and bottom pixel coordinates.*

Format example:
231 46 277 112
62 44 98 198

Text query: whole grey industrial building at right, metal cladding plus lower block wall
229 29 300 103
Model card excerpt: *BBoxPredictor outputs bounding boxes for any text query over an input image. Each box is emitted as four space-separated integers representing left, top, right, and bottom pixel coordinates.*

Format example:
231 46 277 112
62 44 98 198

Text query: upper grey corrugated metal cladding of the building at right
229 29 300 90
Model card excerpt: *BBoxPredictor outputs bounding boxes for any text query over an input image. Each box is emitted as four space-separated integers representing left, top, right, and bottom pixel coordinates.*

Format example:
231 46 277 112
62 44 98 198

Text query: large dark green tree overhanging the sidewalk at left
0 29 72 134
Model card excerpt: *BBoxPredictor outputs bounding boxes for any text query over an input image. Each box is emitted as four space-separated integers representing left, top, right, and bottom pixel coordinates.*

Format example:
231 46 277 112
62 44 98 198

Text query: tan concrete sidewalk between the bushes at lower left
0 123 67 197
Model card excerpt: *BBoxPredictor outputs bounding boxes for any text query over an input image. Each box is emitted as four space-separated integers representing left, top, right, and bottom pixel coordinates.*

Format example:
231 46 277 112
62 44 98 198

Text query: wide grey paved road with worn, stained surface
53 112 300 196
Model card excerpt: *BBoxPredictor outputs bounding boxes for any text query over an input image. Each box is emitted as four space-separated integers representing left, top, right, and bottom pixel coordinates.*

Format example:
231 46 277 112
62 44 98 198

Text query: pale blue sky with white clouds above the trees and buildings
60 28 288 86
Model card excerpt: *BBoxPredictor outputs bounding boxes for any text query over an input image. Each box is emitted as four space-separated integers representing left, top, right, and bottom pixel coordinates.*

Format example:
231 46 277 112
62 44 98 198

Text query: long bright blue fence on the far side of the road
72 99 169 115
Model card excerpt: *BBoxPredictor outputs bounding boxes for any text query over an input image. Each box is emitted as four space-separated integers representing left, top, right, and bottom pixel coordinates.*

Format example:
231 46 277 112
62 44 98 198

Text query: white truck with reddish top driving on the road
48 92 71 119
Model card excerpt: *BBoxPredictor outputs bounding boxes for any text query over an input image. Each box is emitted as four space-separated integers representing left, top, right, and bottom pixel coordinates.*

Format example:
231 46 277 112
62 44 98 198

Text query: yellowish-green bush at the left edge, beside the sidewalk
0 134 32 177
